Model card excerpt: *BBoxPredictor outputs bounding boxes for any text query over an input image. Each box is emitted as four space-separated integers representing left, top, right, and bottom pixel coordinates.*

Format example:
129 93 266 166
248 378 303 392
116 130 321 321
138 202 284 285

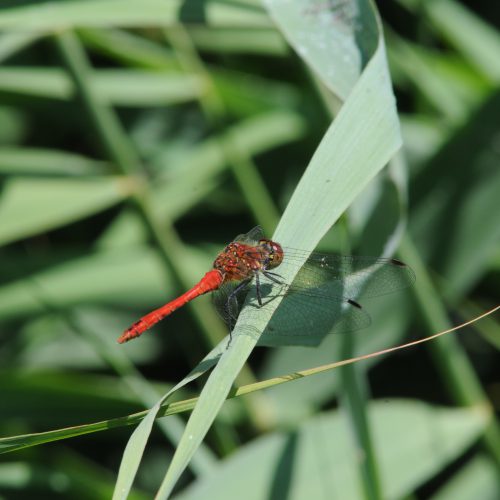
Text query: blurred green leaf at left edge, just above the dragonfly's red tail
0 247 168 319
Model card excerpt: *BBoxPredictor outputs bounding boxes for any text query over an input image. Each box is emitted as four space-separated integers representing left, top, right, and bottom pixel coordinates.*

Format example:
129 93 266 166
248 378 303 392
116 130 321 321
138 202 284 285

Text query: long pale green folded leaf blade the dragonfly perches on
152 1 401 498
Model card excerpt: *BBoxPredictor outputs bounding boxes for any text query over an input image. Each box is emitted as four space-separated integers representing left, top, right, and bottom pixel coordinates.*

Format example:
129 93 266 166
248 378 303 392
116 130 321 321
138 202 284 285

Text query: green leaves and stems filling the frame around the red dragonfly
0 0 500 500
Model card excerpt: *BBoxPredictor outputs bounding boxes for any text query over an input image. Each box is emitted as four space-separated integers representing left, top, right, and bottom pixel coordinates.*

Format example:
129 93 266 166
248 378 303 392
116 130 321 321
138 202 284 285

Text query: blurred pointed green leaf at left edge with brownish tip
0 177 134 245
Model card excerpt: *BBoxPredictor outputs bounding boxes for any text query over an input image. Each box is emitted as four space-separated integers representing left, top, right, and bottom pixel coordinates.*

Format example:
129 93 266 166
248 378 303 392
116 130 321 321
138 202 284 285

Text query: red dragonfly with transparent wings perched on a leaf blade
118 226 415 345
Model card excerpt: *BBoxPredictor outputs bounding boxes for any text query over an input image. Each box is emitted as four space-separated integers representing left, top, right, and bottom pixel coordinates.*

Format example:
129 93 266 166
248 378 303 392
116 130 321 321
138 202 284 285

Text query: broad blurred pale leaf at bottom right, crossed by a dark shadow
175 399 488 500
